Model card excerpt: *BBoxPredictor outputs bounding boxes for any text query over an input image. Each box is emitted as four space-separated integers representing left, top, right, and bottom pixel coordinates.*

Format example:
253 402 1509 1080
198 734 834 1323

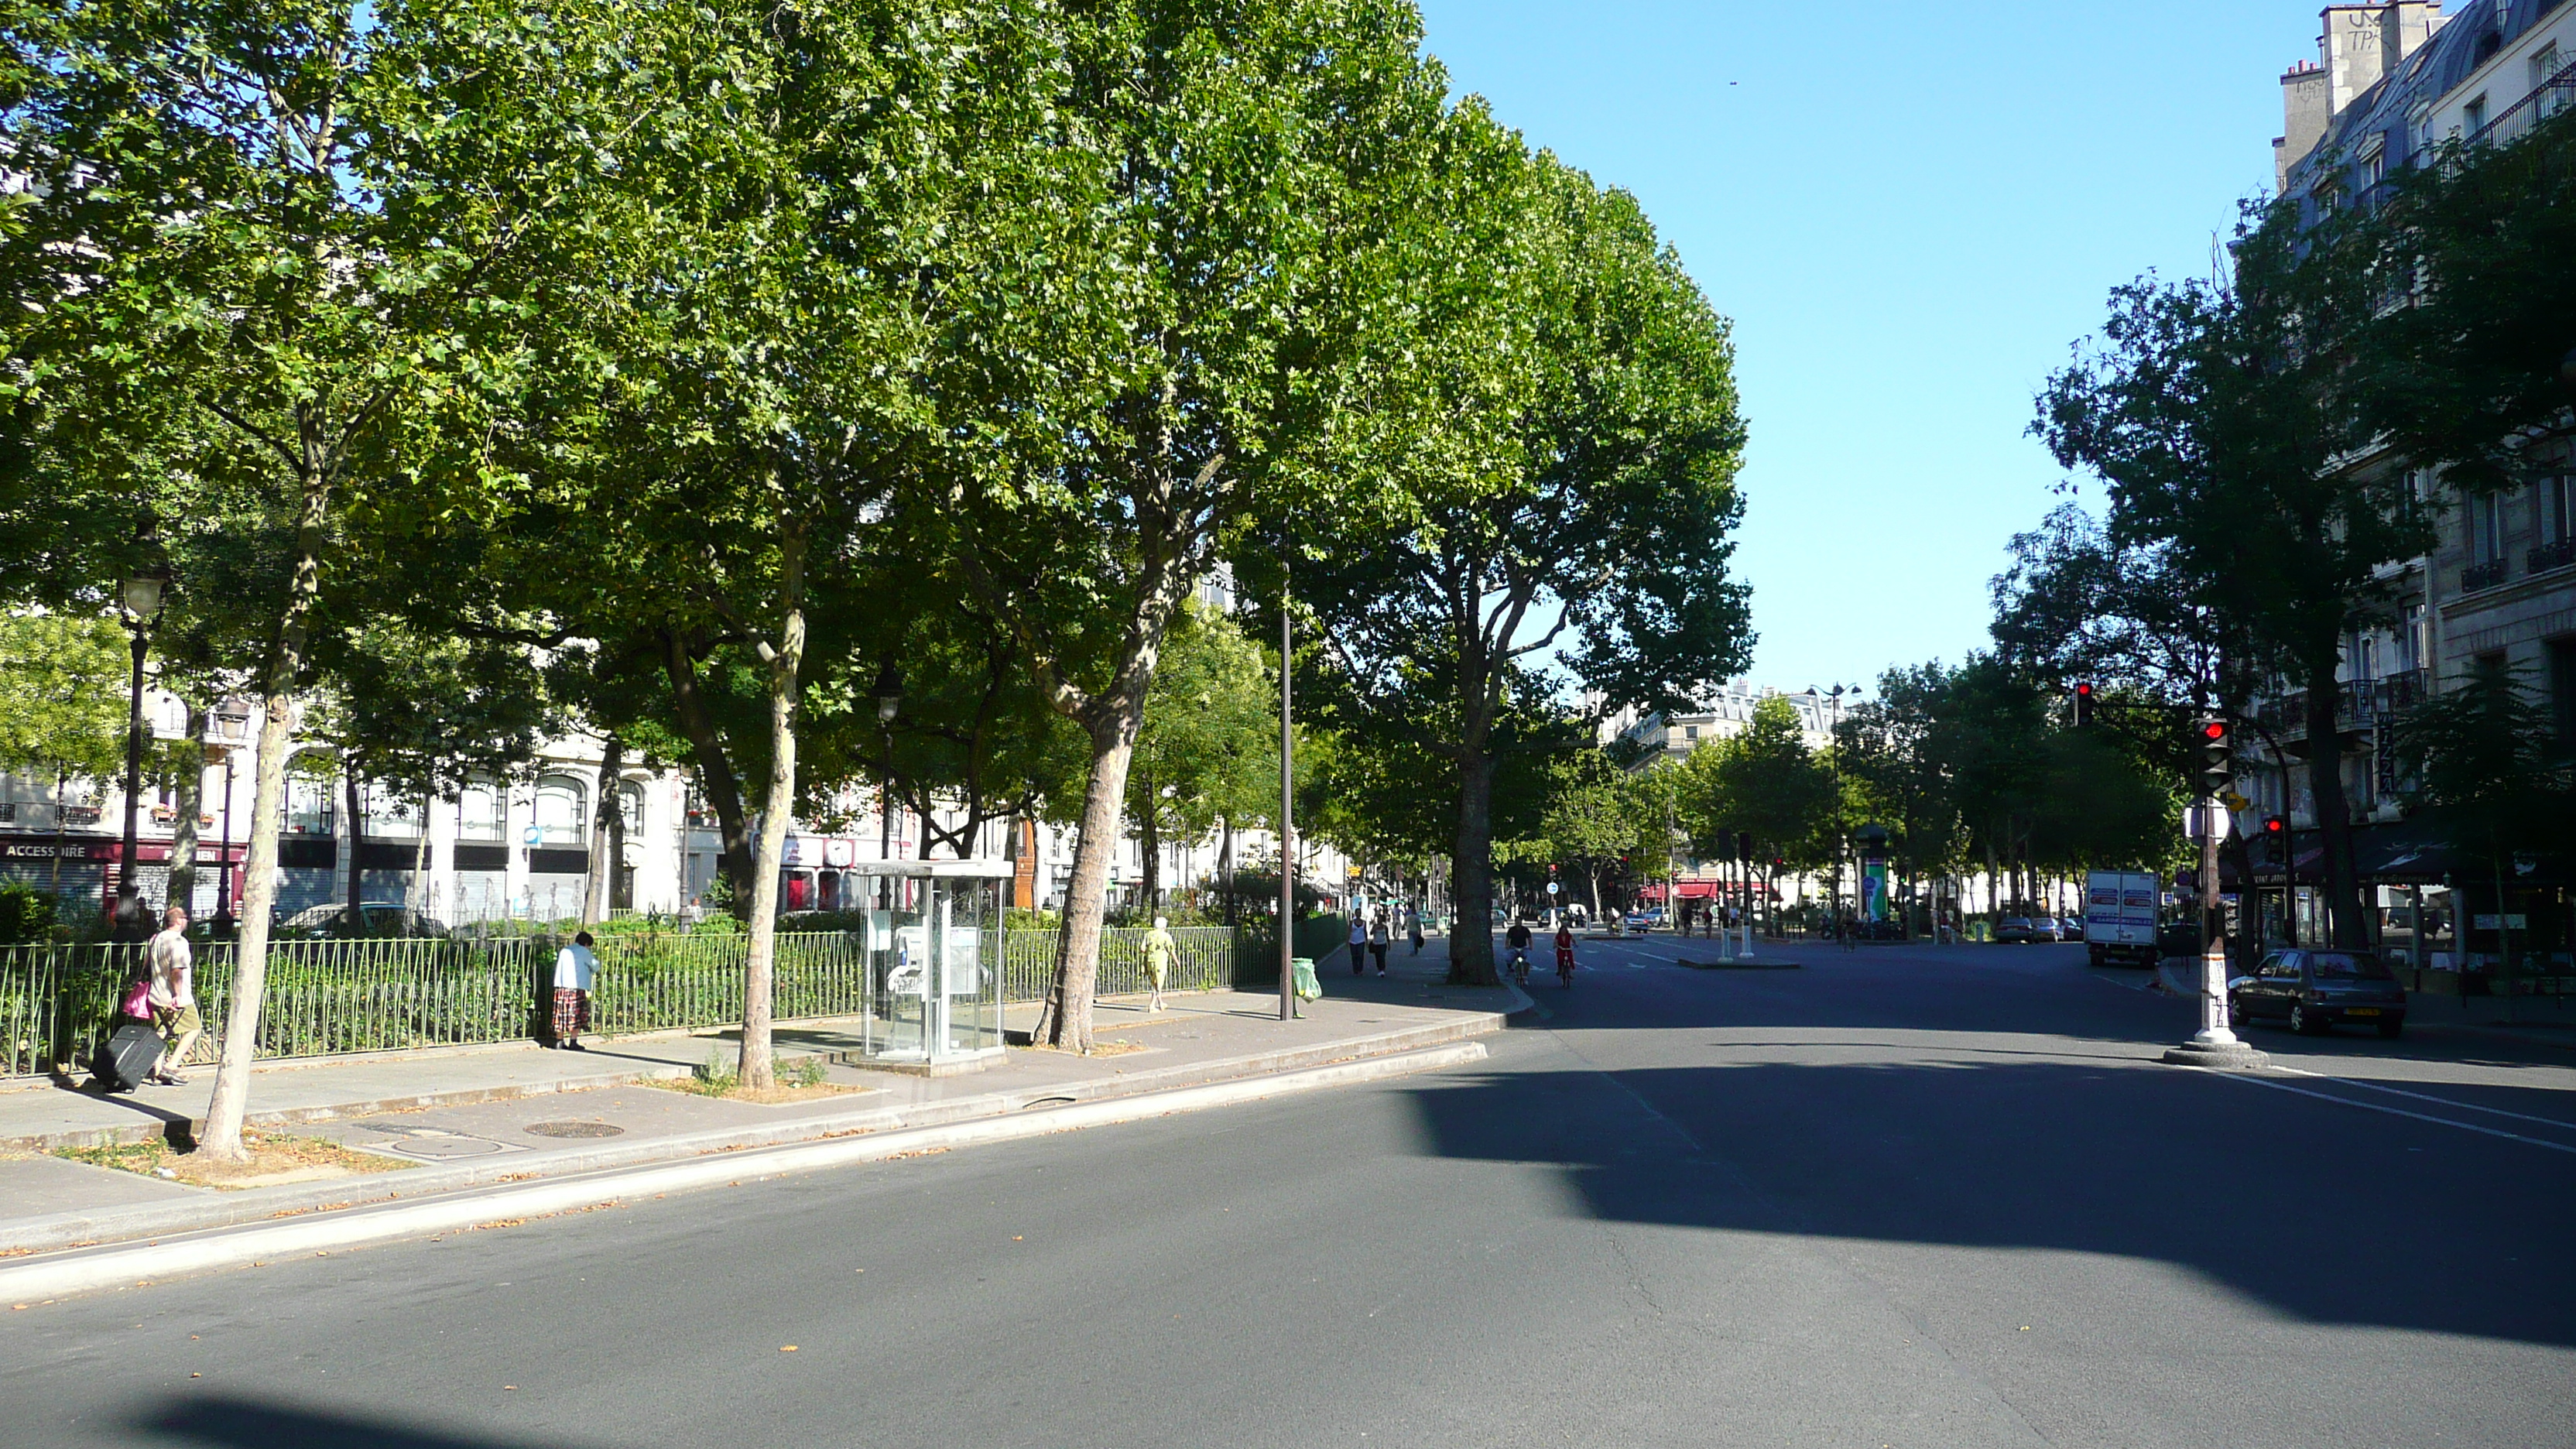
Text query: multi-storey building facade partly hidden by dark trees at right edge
2241 0 2576 969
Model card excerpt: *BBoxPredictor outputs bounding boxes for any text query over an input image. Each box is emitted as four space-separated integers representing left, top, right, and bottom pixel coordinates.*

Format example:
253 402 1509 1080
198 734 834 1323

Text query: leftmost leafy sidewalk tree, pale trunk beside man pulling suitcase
0 0 559 1158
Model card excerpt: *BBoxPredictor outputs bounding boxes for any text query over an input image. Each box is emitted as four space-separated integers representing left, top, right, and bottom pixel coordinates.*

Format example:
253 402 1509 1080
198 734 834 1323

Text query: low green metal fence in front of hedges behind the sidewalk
0 918 1342 1075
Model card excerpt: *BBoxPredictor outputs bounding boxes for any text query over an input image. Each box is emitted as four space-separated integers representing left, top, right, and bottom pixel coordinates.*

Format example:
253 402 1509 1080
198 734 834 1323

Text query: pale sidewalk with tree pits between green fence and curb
0 951 1528 1253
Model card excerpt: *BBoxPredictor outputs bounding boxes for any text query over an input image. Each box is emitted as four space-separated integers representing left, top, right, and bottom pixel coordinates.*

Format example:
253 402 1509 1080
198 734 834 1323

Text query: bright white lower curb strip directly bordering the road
0 1042 1486 1307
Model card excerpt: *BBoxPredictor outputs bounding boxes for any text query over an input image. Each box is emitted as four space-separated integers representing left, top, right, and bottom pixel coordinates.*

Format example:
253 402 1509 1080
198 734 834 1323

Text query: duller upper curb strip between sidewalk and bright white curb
0 1011 1505 1253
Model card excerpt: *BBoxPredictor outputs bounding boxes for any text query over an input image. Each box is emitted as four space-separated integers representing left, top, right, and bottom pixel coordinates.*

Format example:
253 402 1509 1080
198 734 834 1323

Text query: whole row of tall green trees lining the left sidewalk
0 0 1746 1155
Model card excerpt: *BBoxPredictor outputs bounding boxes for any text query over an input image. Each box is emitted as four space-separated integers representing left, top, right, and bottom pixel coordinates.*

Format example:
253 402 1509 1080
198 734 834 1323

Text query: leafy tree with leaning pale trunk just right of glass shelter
920 0 1437 1050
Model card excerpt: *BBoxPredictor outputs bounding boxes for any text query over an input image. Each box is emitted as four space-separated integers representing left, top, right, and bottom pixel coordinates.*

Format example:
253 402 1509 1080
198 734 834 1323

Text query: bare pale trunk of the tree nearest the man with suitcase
196 472 330 1163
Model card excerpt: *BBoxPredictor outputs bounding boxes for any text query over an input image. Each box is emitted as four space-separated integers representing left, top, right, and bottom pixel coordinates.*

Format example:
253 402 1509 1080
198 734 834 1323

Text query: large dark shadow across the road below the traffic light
1414 1052 2576 1346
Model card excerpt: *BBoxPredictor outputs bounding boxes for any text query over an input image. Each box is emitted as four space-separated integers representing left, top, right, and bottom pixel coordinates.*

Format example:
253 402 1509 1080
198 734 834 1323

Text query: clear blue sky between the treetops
1422 0 2318 688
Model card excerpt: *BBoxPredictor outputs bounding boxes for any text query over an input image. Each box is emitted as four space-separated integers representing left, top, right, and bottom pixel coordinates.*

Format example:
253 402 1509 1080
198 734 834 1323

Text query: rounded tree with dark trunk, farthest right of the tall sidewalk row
1283 123 1749 982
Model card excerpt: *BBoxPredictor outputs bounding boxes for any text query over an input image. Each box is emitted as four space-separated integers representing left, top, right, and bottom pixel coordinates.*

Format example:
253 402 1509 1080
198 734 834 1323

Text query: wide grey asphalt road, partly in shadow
0 938 2576 1449
